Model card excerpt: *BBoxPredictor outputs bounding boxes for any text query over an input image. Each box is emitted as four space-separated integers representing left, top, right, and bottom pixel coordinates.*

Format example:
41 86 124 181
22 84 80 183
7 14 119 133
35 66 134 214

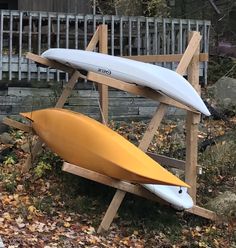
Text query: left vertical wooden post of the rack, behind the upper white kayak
98 24 108 124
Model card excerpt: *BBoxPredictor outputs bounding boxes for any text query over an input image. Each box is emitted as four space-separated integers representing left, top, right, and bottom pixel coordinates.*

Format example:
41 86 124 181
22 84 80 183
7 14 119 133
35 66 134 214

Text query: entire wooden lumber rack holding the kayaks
3 25 217 233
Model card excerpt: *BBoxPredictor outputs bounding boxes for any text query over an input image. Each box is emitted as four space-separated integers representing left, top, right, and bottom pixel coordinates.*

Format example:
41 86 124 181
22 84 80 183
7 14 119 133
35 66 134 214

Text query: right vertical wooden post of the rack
185 32 200 203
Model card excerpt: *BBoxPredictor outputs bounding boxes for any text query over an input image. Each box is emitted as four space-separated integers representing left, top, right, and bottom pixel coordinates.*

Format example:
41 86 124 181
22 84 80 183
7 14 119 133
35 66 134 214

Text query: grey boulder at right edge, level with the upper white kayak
209 77 236 109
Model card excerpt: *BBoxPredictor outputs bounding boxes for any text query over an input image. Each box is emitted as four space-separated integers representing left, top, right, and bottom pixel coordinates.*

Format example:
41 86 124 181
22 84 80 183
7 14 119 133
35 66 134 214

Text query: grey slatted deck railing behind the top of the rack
0 10 210 82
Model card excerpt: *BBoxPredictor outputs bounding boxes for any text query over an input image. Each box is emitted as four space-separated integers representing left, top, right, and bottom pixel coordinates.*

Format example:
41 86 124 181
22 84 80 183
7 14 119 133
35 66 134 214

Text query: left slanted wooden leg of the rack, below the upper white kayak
22 71 80 171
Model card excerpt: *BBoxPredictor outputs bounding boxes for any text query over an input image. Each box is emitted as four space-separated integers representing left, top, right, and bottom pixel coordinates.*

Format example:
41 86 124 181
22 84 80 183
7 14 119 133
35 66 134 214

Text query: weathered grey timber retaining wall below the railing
0 83 184 121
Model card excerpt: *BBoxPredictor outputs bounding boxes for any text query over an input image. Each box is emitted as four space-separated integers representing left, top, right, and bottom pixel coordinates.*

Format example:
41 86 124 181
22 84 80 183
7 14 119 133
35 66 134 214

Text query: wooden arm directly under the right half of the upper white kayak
87 72 195 111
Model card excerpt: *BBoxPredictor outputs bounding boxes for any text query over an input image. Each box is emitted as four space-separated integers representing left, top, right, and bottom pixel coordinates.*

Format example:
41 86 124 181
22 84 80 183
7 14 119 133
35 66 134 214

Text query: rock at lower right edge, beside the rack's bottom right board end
207 191 236 217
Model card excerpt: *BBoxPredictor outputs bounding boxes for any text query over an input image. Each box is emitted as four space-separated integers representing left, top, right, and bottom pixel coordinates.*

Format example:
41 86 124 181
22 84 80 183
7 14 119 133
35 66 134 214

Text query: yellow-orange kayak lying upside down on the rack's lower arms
21 108 189 187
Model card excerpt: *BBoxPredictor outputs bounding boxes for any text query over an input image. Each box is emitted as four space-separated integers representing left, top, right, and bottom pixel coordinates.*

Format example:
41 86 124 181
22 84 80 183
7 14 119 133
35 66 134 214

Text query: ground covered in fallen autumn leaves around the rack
0 118 236 248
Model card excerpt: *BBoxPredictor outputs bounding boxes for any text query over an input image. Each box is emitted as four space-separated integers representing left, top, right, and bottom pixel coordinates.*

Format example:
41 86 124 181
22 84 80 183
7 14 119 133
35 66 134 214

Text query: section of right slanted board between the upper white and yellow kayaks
139 103 168 152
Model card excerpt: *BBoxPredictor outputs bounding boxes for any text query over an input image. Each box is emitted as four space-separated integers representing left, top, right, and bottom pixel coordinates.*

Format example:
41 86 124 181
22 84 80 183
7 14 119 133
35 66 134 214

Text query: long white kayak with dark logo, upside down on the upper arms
42 48 210 116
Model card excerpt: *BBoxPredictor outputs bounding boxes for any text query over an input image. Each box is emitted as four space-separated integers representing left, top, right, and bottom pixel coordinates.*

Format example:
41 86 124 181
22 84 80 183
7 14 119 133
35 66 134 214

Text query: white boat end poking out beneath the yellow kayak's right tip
142 184 193 210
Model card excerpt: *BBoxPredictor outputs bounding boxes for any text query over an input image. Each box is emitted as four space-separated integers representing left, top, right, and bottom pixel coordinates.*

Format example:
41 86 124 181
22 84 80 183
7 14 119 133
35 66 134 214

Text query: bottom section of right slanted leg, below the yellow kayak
97 189 126 233
